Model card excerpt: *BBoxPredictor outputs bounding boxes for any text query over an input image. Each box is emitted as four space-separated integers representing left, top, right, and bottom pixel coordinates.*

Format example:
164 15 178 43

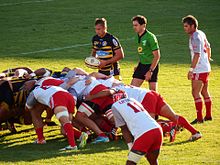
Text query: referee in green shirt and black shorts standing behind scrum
131 15 160 91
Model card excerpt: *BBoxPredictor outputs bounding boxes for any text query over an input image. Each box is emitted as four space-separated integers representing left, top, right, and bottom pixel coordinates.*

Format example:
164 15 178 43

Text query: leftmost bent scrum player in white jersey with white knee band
26 86 88 150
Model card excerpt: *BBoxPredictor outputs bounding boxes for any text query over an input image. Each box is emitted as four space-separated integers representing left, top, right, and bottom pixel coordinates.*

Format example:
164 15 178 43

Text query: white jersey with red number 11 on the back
112 98 160 140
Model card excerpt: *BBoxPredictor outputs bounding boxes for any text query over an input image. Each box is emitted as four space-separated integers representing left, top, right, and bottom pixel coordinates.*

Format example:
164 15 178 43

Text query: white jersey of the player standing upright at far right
189 30 211 73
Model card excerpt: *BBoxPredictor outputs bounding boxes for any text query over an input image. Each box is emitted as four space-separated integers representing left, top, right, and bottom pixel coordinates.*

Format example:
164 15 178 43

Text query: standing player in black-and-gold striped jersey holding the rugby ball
92 18 124 80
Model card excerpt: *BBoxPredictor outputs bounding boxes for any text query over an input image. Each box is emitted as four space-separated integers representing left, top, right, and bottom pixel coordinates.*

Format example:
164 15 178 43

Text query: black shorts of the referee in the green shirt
133 63 159 82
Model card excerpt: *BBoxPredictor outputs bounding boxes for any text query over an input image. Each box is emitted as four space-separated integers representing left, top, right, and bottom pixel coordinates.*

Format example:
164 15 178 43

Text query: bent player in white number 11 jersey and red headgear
112 98 163 165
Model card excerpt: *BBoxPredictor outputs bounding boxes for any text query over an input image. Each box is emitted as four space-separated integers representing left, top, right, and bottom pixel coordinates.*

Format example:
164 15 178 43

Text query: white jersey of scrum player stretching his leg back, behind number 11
114 85 150 103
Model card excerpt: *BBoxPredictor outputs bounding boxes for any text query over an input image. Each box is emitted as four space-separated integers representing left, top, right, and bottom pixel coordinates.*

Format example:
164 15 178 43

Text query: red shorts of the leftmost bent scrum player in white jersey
50 91 75 113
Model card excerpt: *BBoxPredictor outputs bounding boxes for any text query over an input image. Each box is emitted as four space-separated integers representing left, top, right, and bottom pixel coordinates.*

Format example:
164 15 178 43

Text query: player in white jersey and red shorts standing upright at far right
182 15 212 124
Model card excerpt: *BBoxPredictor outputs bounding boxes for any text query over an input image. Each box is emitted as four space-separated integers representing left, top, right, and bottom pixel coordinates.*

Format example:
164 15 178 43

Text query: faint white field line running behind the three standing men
7 33 178 55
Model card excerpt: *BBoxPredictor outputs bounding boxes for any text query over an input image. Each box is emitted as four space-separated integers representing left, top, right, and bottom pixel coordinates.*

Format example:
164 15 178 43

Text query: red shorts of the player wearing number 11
131 128 163 153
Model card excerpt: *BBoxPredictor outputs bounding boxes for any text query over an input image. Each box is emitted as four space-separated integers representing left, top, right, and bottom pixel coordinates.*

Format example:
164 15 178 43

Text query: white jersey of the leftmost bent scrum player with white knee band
32 86 67 108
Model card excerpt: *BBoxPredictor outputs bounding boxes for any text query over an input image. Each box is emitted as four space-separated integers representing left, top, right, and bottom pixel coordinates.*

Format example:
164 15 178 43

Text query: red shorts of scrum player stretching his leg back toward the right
141 91 166 115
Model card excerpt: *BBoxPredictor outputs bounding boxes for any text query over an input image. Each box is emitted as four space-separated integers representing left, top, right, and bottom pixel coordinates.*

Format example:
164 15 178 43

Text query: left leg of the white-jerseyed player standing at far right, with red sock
192 80 204 124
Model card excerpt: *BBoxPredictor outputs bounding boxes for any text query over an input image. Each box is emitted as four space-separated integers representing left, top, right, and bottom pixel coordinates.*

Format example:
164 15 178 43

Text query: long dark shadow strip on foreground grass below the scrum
0 137 127 163
